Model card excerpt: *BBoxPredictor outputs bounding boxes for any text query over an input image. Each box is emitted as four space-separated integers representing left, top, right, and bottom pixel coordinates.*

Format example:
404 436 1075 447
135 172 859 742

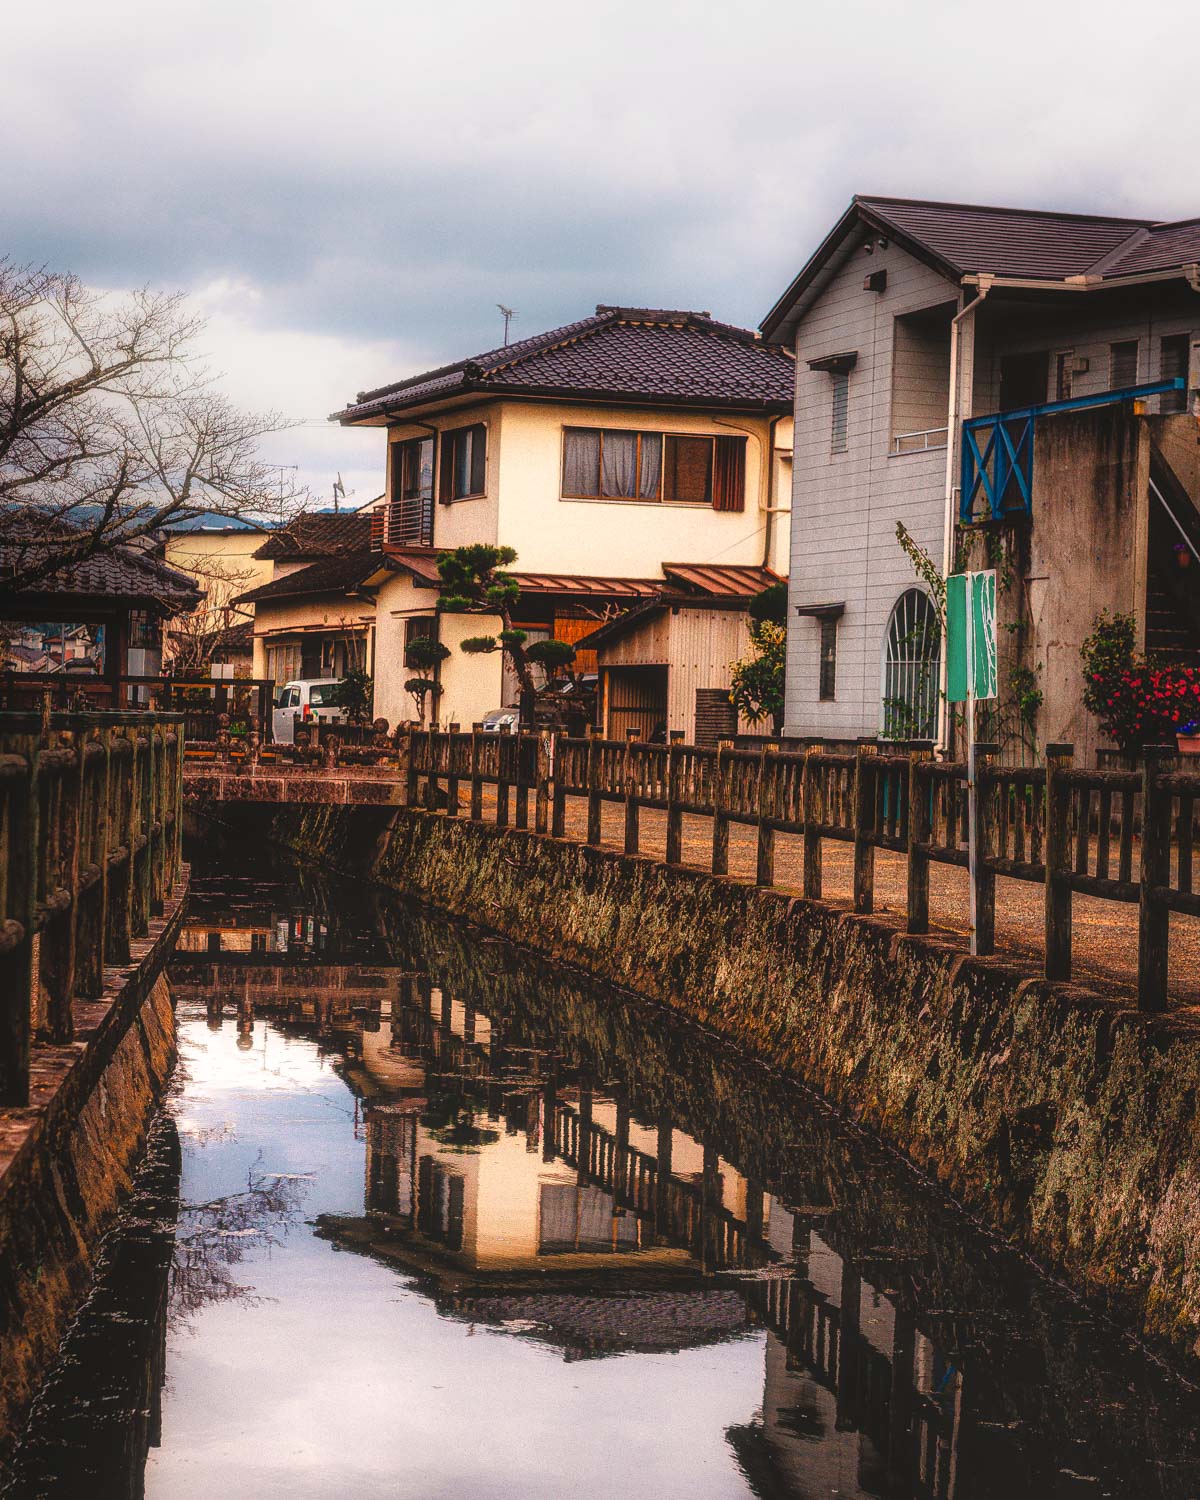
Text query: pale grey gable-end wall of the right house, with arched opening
785 239 957 738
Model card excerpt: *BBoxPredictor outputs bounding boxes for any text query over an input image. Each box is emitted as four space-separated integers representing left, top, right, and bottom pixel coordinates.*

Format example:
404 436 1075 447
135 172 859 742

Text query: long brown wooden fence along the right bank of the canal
401 728 1200 1011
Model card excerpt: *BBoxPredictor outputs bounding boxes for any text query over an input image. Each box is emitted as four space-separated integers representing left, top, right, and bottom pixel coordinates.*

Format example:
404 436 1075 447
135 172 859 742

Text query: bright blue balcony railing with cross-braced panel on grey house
959 380 1187 527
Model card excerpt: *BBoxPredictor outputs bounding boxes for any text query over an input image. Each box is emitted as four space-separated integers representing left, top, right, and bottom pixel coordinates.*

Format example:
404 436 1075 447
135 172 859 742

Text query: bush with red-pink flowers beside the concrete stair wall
1080 611 1200 755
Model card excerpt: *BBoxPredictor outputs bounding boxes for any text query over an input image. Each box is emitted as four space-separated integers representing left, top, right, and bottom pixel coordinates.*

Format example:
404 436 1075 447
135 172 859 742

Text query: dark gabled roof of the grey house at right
762 195 1200 338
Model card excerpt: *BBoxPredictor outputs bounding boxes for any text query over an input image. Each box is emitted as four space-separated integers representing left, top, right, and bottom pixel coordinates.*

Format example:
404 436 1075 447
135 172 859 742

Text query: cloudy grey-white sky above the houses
0 0 1200 504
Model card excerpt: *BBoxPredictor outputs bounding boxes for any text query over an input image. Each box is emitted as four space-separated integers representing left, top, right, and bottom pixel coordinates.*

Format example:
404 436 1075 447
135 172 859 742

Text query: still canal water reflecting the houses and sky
6 848 1200 1500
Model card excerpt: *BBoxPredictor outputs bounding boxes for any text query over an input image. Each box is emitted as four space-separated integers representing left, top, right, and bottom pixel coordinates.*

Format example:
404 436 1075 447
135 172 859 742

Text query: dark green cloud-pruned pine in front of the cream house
438 542 575 729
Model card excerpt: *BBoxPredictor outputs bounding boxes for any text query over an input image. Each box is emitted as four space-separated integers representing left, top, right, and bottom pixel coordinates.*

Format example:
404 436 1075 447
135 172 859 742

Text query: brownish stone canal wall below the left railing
0 882 186 1452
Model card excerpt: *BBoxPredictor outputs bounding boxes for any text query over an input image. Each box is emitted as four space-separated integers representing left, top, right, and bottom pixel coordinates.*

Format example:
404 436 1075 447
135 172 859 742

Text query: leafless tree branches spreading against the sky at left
0 260 302 588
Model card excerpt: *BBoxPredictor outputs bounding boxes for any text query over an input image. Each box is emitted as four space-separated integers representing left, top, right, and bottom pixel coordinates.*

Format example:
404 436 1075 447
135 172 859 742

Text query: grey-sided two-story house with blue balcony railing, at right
762 198 1200 756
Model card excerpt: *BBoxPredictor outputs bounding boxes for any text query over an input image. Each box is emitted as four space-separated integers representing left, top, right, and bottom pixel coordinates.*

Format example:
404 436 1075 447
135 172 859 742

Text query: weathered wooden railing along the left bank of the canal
0 713 183 1106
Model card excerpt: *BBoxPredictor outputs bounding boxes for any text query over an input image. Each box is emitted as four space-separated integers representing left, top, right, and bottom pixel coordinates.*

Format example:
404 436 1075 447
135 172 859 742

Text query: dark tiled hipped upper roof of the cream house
336 306 795 422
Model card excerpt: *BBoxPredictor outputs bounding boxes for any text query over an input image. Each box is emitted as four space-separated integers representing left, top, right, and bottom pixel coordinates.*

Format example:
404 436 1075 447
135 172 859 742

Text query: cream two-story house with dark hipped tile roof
338 306 794 728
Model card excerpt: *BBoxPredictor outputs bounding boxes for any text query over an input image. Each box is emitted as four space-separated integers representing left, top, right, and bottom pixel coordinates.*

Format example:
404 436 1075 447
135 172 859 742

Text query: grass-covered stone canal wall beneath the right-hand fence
259 809 1200 1374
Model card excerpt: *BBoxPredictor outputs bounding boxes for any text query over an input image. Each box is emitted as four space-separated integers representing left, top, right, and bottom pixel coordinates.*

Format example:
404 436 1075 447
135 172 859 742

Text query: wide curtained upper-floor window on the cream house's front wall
563 428 746 510
